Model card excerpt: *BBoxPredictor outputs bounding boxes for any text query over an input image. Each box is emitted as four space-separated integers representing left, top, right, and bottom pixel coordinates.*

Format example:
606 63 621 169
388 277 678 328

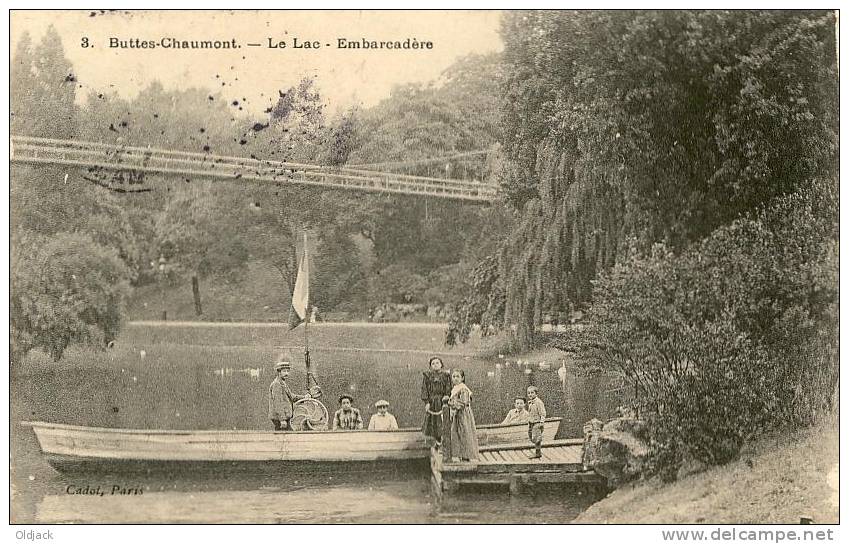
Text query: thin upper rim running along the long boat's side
20 417 563 436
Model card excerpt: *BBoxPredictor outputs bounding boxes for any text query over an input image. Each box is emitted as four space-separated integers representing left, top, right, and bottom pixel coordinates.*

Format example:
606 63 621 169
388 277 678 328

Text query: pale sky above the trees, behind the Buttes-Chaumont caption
10 10 503 114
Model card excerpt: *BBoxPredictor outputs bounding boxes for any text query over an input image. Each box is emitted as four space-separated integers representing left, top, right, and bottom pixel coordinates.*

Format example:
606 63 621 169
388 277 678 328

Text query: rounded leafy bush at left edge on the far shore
10 231 130 361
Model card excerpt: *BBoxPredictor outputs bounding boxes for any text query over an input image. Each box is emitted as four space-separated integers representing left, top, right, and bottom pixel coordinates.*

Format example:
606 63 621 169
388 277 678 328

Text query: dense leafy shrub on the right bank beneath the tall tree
560 181 839 476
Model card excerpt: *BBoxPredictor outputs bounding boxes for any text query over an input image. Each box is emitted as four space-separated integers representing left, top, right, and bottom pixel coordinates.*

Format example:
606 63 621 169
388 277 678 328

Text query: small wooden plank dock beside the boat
430 438 607 499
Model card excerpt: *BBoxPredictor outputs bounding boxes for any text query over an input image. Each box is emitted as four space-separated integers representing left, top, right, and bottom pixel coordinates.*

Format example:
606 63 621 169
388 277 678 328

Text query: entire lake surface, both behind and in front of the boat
10 325 615 523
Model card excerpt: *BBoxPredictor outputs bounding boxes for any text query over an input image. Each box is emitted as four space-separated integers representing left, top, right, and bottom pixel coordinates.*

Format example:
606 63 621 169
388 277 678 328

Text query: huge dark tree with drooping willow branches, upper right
464 11 838 344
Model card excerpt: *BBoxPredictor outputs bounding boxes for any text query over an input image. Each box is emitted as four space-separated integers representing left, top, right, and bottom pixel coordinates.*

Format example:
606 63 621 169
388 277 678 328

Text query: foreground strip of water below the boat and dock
34 468 599 523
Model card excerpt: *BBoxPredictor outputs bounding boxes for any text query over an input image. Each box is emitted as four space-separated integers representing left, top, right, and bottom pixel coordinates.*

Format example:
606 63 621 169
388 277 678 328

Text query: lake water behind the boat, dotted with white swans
15 344 615 436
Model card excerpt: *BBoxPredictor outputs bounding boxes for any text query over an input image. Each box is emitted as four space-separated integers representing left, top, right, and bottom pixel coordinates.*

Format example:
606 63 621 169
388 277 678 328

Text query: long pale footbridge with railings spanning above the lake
9 136 498 204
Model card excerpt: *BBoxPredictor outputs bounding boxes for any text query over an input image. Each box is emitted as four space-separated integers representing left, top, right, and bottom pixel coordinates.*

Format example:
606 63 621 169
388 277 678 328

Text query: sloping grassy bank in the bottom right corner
575 418 839 524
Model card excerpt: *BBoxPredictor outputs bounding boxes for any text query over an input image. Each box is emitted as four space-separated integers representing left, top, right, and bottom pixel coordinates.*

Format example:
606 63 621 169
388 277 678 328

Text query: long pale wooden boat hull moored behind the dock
22 418 561 470
